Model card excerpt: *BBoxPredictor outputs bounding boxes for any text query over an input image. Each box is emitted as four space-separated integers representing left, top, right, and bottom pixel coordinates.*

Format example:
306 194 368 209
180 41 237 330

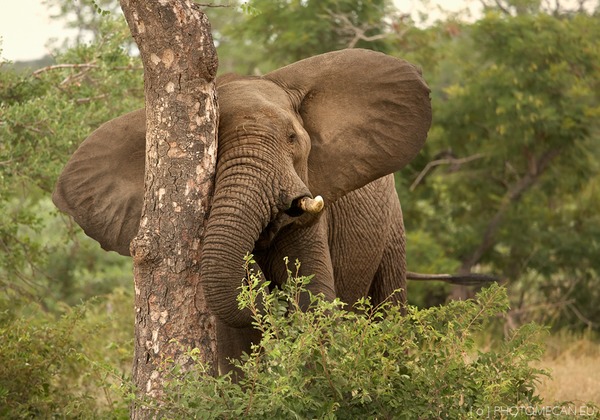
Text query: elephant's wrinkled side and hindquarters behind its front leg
328 175 406 305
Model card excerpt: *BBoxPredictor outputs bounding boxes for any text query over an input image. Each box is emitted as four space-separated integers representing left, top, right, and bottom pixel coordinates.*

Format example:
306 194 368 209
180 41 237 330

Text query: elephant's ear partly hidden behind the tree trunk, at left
52 109 146 255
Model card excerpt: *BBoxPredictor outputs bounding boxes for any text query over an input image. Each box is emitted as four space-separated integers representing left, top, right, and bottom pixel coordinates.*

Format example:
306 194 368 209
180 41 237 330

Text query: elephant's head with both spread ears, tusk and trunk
53 49 431 326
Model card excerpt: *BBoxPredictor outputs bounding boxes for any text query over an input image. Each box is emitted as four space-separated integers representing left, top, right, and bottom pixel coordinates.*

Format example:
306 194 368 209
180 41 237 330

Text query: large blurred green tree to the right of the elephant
399 7 600 329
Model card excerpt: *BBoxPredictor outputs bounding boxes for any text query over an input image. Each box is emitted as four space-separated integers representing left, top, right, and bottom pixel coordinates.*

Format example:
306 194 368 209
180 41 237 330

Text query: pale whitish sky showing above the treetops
0 0 478 61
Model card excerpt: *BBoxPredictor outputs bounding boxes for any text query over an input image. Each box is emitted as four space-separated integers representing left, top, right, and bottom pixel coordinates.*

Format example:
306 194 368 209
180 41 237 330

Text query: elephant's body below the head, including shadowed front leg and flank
253 175 406 305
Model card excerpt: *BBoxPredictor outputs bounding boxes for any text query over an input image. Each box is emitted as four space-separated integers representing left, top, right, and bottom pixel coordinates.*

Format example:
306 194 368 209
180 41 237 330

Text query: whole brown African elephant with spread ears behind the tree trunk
53 49 431 370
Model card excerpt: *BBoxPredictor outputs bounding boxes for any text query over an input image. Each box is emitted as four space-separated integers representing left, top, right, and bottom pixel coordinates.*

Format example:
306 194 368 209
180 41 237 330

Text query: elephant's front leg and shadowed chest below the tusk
256 215 336 309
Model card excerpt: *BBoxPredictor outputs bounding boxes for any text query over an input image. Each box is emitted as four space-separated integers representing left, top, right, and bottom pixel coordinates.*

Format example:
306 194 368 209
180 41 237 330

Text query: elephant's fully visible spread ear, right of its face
265 49 431 201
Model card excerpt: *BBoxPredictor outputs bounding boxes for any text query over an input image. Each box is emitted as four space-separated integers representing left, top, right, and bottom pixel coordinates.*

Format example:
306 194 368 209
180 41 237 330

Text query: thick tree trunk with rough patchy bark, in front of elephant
120 0 218 418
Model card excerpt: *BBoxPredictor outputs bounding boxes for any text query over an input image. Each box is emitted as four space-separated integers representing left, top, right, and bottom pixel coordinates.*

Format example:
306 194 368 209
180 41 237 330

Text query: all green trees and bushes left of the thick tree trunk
0 18 143 418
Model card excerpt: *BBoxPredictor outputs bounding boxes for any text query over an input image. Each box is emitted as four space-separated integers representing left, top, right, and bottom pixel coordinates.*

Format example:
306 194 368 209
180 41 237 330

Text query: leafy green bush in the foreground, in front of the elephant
148 264 545 418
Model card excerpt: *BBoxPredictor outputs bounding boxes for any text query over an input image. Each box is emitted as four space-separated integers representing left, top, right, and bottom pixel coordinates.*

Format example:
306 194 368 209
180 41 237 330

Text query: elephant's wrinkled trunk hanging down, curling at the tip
201 177 271 327
